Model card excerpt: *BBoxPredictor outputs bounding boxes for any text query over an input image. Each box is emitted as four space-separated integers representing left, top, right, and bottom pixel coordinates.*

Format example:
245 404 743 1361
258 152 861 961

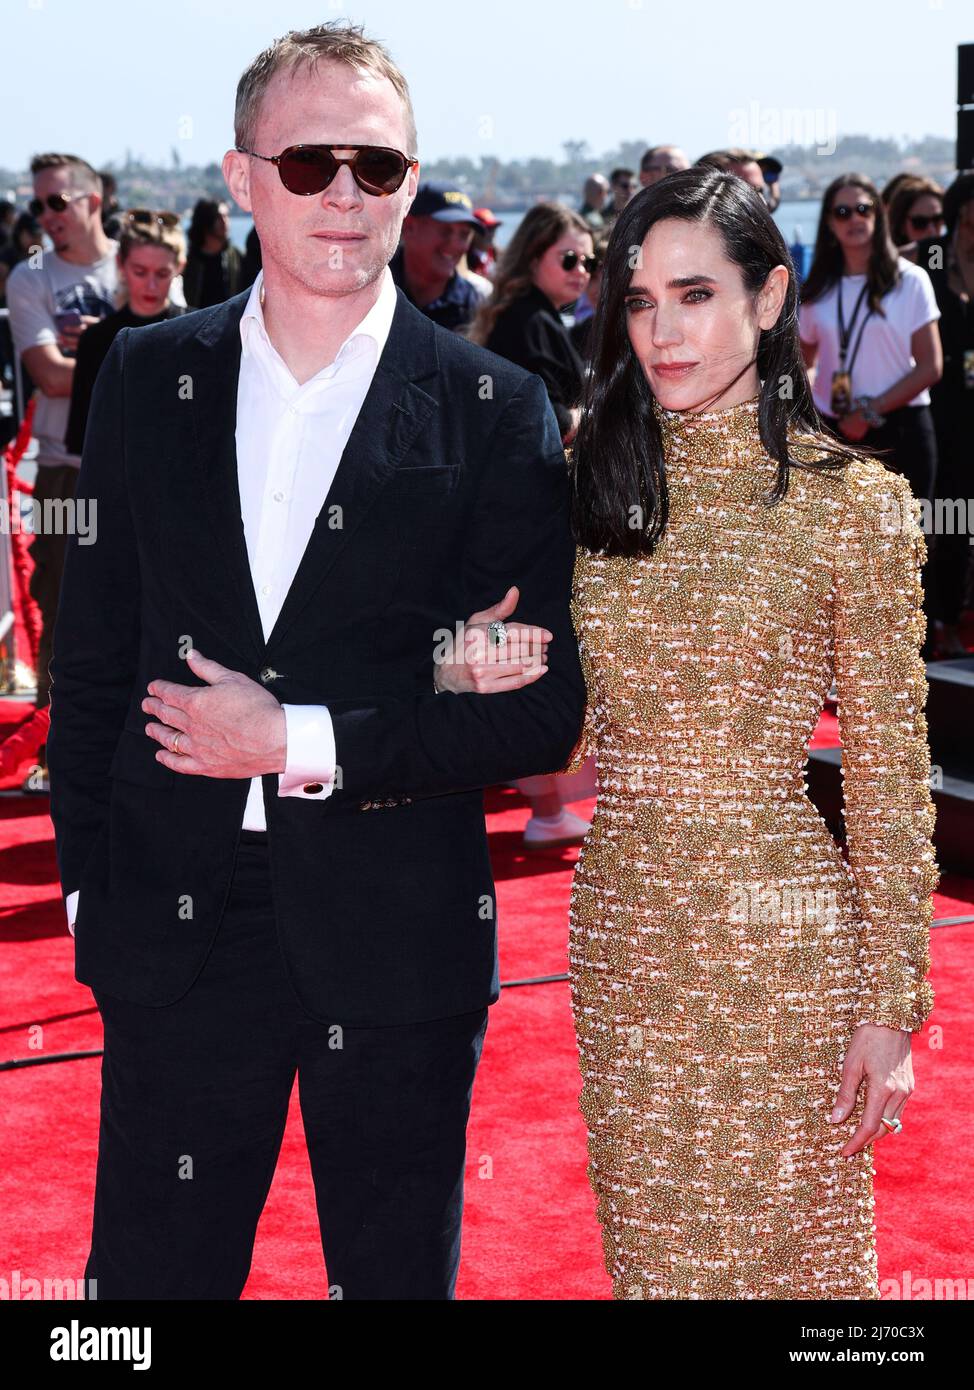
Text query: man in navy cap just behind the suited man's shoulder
389 183 484 329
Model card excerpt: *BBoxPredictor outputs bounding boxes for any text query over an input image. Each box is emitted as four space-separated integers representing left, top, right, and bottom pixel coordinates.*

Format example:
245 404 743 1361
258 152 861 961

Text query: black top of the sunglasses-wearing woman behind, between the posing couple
486 285 585 435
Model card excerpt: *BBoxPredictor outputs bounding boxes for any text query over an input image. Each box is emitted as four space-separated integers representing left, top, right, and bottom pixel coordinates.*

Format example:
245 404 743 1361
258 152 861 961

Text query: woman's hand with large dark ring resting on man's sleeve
434 587 553 695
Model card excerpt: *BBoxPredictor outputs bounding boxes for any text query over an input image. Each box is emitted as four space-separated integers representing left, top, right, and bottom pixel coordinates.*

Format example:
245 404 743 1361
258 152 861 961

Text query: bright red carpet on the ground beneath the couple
0 705 974 1300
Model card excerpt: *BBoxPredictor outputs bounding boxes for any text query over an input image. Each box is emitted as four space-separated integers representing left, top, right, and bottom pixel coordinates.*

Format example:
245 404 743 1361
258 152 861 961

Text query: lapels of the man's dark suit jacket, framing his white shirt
193 291 438 662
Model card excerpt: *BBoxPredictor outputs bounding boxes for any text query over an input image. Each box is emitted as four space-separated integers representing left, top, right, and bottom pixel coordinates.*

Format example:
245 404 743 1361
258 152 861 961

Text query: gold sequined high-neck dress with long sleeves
570 402 936 1298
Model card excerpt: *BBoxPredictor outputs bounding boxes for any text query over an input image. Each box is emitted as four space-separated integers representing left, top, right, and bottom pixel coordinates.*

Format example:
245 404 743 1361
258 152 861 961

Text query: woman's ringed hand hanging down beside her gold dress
832 1023 913 1158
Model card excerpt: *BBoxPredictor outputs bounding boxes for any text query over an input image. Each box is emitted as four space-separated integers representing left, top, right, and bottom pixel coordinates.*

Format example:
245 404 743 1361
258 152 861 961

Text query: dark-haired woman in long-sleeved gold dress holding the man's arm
441 168 936 1300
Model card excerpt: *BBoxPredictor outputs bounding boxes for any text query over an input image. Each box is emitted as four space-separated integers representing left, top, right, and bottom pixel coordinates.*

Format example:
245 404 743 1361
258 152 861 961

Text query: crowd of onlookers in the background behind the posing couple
0 145 974 811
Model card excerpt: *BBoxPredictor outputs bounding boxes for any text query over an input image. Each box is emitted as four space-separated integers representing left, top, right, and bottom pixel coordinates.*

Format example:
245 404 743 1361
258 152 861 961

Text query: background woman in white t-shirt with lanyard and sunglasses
799 174 943 500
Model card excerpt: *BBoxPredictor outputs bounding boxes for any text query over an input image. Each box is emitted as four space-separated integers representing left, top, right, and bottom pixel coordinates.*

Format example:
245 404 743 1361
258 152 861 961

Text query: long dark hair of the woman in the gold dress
571 167 855 555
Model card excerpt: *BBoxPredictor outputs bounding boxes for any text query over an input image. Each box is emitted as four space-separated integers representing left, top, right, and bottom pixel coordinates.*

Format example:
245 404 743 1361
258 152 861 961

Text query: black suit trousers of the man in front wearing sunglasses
85 831 488 1300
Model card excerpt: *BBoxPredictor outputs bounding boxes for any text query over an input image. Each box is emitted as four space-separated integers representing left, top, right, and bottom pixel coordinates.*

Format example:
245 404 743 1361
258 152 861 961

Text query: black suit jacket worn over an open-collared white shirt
47 282 585 1026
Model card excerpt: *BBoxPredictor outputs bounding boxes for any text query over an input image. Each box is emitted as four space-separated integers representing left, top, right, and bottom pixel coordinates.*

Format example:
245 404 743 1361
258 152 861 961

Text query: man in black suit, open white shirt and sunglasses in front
49 25 584 1298
